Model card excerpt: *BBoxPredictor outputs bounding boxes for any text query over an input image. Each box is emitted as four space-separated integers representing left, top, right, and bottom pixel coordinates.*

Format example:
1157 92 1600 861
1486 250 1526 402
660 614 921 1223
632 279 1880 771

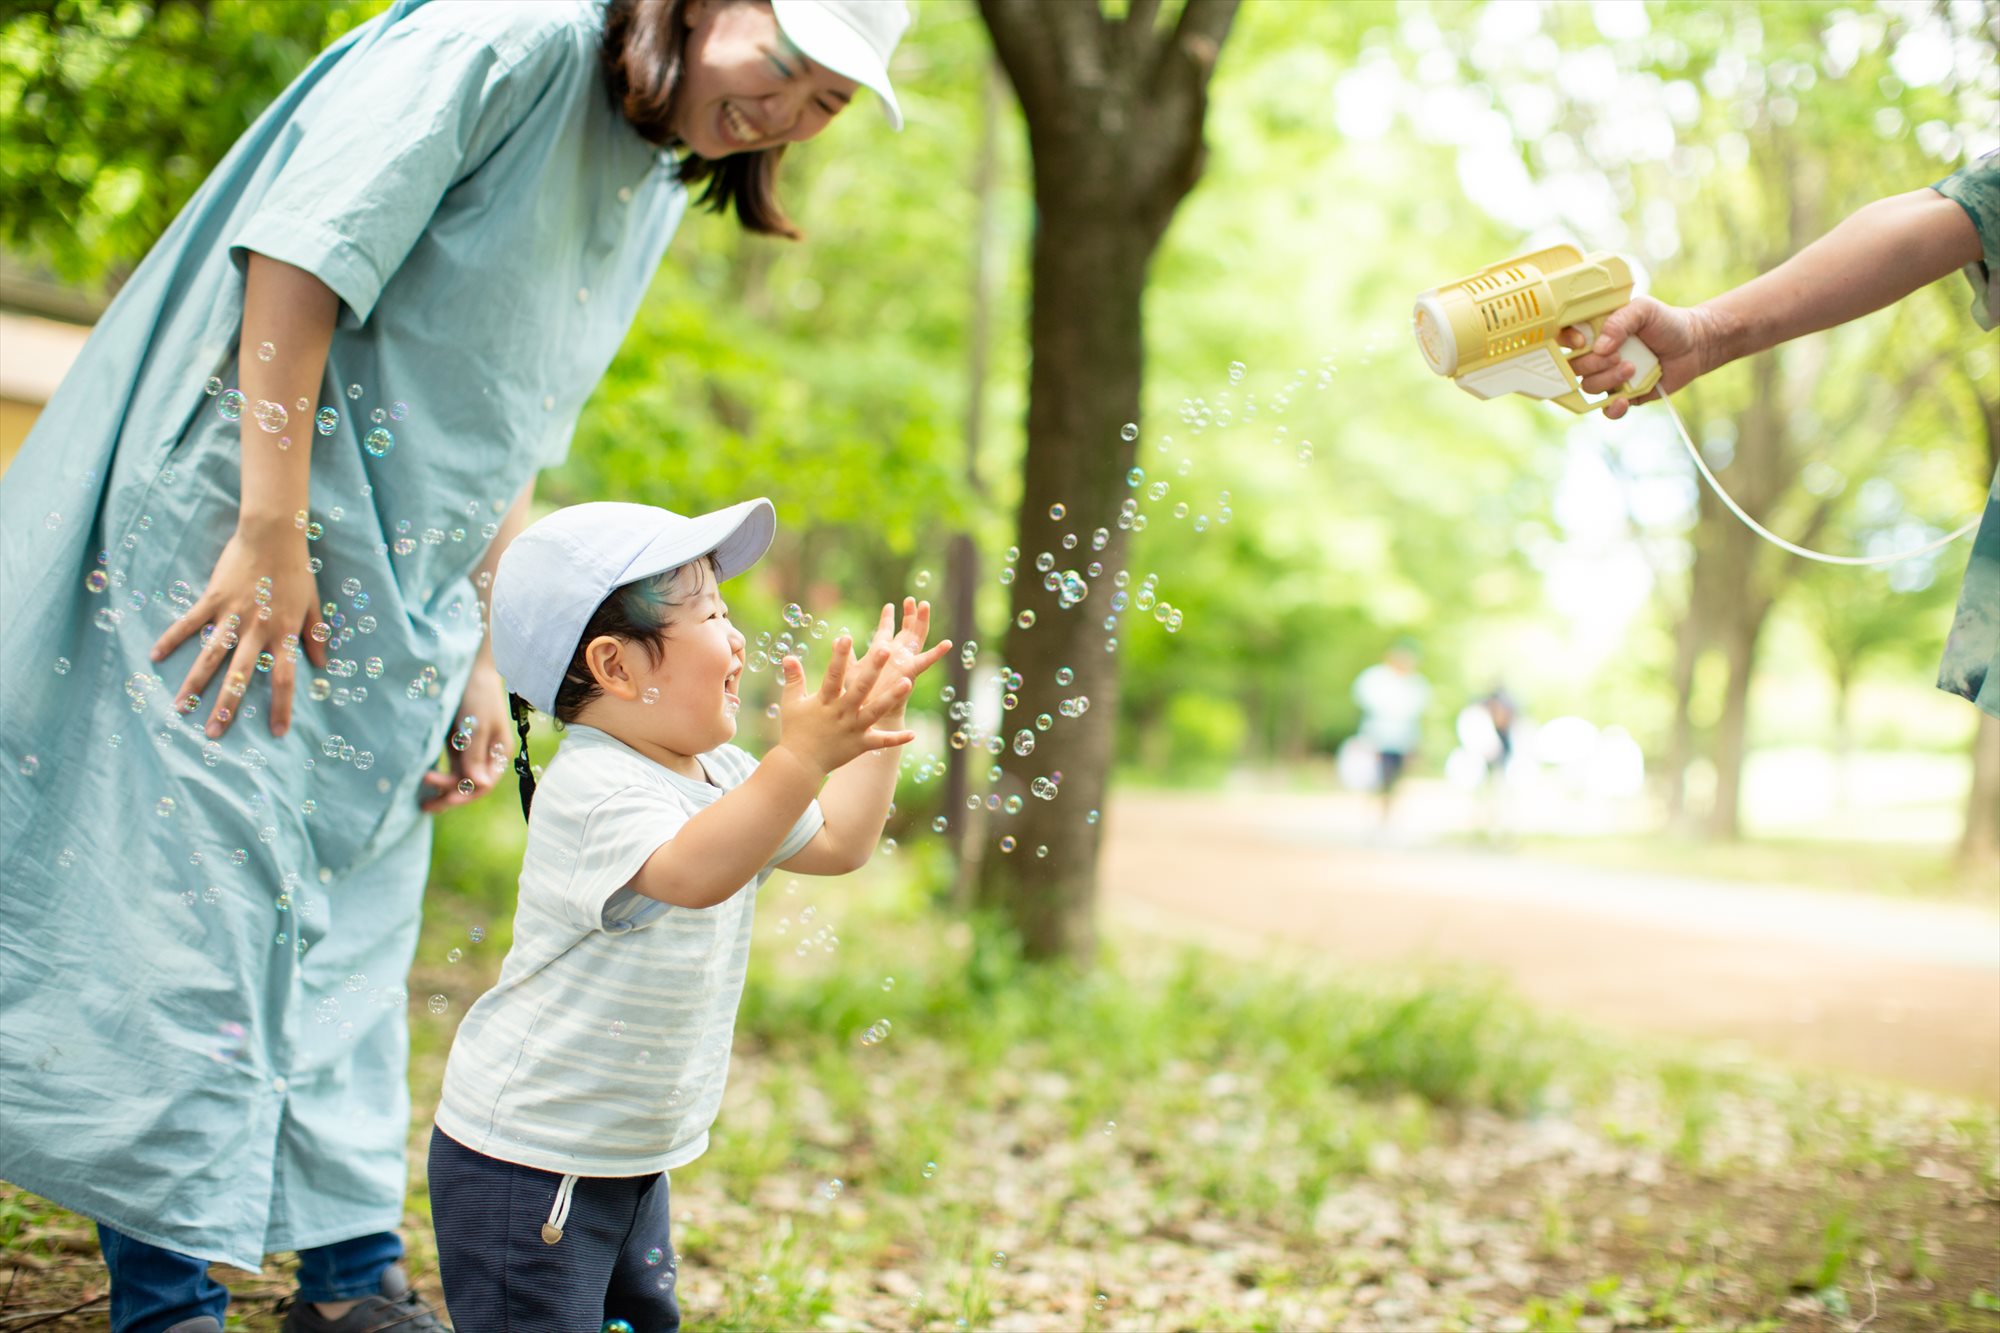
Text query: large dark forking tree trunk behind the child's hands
976 0 1236 959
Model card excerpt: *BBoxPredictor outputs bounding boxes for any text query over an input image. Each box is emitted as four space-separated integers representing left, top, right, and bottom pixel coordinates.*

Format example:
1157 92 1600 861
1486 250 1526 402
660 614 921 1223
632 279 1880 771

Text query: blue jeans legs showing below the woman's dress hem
98 1223 402 1333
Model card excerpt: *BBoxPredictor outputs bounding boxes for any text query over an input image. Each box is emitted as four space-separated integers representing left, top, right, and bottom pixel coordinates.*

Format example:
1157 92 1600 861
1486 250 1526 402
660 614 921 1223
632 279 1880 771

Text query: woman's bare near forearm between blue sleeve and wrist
236 254 340 528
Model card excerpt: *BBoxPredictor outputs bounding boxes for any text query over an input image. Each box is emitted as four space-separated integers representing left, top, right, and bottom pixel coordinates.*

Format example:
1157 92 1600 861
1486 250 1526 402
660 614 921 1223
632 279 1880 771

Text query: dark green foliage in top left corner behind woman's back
0 0 386 288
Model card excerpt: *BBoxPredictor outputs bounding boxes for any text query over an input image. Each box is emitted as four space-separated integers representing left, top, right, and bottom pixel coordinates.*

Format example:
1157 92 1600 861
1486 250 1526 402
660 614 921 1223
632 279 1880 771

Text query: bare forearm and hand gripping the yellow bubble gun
1564 186 1980 420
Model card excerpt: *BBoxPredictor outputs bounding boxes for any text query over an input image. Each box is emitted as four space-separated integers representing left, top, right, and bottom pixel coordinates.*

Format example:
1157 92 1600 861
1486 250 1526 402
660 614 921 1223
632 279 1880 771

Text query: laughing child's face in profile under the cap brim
630 560 744 755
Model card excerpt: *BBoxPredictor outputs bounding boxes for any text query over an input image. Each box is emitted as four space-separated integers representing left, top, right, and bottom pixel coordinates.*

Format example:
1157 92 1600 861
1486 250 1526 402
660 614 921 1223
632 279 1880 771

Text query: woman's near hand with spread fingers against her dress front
152 518 328 739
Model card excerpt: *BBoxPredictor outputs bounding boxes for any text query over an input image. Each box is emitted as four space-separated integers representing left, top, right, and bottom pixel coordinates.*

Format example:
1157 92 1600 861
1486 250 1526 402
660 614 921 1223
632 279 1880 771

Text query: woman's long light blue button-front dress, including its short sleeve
0 0 686 1269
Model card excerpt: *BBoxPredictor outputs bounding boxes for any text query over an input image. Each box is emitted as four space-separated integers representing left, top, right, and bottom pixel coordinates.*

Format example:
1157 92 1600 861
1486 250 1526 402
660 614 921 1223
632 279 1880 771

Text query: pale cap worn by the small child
492 498 778 713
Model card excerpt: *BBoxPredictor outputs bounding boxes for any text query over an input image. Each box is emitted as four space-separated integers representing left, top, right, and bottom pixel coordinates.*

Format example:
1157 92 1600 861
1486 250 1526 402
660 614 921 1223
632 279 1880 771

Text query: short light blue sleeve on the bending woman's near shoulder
230 4 570 324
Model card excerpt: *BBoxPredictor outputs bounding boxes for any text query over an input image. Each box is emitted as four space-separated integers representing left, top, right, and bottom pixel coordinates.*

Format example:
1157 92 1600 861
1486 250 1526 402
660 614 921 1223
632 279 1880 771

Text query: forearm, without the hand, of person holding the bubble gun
1696 188 1980 370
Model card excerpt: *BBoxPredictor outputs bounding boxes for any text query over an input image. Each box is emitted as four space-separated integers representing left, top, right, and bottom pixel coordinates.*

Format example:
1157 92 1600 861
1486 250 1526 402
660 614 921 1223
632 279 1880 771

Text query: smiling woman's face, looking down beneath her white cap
674 0 860 158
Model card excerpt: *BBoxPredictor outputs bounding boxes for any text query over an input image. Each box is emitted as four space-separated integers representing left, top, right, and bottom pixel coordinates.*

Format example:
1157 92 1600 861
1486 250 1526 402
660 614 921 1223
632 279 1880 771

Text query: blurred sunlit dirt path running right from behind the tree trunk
1104 793 2000 1101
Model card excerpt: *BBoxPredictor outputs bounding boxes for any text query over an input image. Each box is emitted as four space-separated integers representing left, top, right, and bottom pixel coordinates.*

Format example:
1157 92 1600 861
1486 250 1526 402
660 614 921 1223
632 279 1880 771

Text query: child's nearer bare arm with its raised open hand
632 636 912 909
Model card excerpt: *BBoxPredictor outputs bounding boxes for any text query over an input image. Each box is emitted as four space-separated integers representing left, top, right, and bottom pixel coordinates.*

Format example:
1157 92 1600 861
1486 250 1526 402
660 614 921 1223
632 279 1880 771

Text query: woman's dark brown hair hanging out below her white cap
600 0 800 240
